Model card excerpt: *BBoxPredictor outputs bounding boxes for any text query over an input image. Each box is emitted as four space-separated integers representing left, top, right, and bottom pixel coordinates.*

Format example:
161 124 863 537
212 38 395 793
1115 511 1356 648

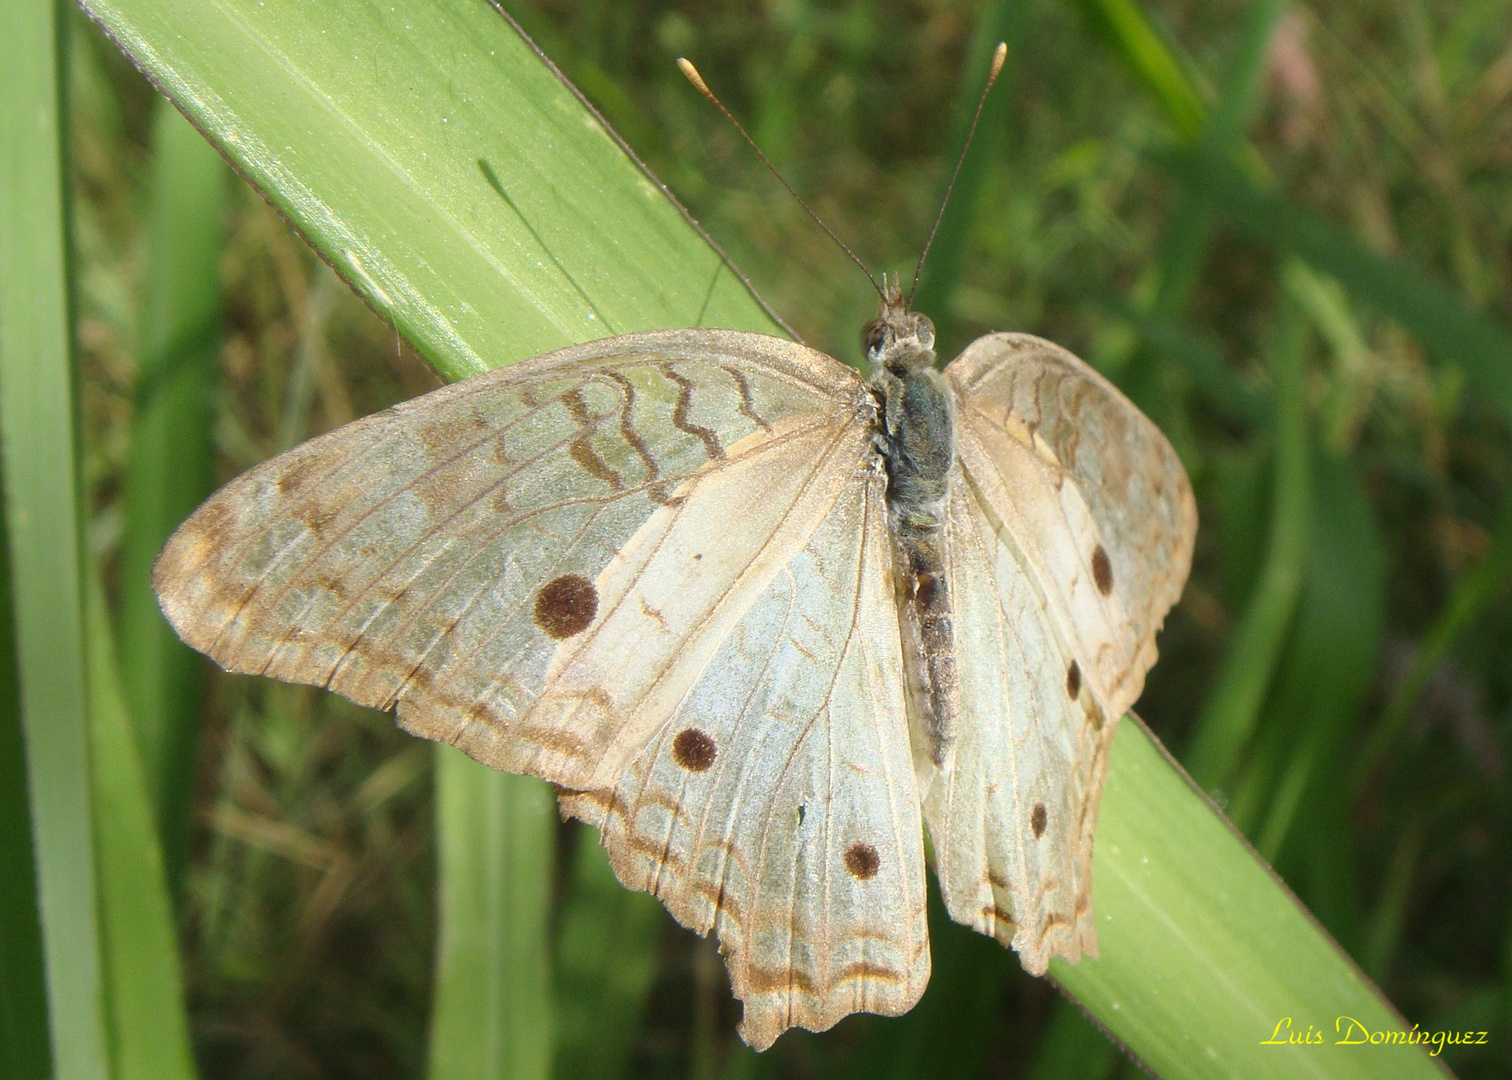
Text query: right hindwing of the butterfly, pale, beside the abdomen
921 467 1113 974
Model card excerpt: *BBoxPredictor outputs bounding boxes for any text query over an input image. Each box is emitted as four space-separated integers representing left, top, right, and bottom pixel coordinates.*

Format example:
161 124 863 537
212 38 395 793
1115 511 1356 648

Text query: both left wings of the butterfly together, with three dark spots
154 323 928 1047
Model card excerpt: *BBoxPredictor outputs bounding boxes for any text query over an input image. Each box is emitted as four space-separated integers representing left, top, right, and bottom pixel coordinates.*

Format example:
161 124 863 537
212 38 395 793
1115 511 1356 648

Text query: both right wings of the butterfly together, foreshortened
921 334 1196 974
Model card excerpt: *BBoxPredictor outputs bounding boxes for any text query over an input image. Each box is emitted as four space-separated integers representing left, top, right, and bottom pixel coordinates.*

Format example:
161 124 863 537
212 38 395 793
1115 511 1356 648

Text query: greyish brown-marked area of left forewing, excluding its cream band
153 330 871 787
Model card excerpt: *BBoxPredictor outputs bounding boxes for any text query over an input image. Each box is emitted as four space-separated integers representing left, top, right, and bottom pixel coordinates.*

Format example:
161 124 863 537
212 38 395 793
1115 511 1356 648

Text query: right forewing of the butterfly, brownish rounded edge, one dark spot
945 334 1198 715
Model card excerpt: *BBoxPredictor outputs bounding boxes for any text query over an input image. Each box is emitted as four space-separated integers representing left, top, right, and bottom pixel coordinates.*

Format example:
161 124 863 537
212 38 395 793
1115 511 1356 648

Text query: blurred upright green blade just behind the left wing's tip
119 101 230 877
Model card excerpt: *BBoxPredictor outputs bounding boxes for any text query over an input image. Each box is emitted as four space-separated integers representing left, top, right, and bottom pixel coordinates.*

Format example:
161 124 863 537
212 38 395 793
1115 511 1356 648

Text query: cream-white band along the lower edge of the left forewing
468 410 871 788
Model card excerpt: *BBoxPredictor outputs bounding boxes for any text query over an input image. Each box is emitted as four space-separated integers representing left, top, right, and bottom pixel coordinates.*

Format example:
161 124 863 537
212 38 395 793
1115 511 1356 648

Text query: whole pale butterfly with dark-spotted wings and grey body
153 264 1196 1048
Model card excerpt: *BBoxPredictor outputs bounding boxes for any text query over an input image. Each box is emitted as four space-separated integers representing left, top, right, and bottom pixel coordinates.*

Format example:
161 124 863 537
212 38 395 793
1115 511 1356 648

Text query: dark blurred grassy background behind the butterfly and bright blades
0 0 1512 1080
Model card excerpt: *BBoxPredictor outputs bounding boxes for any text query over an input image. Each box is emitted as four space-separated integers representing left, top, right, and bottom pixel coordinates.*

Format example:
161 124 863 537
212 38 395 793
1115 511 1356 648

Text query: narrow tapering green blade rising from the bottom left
86 582 195 1080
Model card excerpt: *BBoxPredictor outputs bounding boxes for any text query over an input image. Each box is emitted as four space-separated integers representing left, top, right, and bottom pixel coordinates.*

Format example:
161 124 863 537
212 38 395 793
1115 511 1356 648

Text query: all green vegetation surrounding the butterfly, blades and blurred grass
0 0 1512 1080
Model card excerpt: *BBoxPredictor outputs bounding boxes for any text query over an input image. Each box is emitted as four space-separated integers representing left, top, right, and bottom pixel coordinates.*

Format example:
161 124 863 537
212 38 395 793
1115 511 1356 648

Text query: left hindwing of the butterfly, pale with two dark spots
562 463 930 1050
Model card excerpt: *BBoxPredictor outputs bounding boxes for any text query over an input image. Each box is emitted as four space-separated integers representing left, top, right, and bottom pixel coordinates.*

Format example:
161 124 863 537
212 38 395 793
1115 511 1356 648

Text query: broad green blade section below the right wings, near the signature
1051 718 1444 1080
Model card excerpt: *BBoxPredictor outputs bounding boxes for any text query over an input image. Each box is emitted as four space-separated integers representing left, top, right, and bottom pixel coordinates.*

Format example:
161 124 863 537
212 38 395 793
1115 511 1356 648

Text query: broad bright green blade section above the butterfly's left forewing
75 0 776 380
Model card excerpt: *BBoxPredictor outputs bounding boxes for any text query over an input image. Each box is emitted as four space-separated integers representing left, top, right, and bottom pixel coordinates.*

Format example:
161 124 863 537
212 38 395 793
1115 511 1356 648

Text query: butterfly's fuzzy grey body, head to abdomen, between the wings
862 286 959 765
